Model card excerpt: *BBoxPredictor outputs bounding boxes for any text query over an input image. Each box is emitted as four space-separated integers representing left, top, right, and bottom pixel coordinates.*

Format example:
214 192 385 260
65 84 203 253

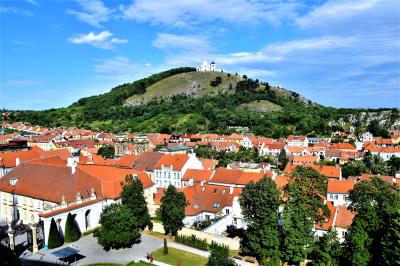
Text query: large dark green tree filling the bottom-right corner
344 177 400 266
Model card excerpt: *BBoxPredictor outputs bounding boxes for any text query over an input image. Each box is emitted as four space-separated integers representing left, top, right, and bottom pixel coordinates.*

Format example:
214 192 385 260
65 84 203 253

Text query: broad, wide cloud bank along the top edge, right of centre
120 0 301 27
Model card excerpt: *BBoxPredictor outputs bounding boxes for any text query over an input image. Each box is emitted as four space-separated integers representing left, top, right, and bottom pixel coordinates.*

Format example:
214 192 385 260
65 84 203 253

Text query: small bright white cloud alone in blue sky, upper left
68 31 128 49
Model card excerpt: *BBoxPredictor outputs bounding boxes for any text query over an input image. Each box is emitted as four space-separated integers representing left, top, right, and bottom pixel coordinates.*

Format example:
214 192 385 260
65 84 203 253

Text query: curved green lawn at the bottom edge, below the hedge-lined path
151 247 208 266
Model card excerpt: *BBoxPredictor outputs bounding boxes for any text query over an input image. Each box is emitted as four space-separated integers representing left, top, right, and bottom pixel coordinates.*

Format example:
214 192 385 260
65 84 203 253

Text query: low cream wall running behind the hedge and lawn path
153 221 240 250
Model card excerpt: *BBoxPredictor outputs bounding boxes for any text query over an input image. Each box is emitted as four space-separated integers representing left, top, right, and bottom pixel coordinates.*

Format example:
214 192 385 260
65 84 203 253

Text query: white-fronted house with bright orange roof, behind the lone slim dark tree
153 153 203 188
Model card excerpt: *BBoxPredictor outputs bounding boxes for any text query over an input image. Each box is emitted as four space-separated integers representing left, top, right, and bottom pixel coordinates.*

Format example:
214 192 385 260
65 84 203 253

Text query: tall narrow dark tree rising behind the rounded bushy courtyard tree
121 175 153 230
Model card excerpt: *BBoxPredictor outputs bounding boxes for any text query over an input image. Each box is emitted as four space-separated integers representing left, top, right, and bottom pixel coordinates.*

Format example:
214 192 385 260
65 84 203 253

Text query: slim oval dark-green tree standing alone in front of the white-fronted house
160 185 187 236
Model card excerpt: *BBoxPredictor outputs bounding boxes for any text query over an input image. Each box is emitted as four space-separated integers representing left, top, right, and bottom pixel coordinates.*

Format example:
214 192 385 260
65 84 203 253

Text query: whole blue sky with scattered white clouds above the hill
0 0 400 110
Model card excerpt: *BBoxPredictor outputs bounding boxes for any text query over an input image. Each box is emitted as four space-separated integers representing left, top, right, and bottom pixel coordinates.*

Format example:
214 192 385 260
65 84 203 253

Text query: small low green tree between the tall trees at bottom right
310 229 342 266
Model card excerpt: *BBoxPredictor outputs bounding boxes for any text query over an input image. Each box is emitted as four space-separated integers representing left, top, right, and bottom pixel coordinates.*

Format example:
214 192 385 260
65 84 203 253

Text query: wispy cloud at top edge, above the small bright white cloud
67 0 114 28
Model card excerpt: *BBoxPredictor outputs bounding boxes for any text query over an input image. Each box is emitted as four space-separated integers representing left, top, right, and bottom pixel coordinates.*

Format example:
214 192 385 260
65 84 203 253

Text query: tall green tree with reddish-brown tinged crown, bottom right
281 167 330 264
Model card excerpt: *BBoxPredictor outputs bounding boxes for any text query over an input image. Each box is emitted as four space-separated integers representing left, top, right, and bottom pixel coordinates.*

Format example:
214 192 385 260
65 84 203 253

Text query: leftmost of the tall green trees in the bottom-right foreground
239 177 280 264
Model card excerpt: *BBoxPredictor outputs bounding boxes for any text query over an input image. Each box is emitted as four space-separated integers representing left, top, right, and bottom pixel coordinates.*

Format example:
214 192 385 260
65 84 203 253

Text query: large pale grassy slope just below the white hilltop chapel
126 71 239 105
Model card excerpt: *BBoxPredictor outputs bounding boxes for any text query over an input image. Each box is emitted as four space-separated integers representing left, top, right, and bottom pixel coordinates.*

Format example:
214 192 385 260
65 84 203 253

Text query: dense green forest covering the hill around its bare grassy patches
3 67 399 138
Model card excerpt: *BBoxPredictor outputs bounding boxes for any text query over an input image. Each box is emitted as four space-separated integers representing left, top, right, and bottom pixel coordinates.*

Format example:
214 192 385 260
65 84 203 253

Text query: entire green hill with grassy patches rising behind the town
9 67 400 137
